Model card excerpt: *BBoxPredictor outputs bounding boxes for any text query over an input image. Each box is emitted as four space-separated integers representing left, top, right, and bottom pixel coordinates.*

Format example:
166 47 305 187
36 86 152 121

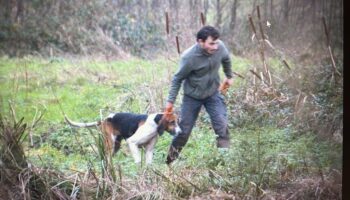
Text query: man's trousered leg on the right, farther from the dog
204 93 230 148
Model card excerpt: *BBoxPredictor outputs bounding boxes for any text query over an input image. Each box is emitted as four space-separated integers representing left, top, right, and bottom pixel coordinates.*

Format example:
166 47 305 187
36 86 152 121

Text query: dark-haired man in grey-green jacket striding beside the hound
166 26 232 164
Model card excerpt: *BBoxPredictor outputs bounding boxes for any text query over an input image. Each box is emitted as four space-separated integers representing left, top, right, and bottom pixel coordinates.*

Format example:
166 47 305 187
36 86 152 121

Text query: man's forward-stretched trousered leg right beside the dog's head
166 95 202 164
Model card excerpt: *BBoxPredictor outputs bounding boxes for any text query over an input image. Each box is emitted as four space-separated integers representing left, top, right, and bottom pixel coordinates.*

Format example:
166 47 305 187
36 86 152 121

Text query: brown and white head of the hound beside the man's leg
155 113 181 136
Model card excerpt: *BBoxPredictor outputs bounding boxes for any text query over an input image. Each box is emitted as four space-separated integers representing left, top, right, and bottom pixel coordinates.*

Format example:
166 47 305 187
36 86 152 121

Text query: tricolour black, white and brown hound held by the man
65 113 181 164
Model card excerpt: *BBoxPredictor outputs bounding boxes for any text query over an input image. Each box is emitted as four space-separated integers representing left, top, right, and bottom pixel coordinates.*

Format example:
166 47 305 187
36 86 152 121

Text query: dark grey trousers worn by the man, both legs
167 92 230 163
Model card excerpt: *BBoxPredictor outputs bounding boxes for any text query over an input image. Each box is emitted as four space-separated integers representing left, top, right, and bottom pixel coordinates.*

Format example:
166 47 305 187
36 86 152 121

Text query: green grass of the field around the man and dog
0 57 342 199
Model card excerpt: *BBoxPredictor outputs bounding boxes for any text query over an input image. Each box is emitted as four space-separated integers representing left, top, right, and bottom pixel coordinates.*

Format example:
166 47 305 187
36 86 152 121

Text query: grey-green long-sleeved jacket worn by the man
168 41 232 103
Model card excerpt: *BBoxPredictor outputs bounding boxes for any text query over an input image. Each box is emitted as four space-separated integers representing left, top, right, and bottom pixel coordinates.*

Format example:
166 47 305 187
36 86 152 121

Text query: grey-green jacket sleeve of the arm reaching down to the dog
168 57 191 103
